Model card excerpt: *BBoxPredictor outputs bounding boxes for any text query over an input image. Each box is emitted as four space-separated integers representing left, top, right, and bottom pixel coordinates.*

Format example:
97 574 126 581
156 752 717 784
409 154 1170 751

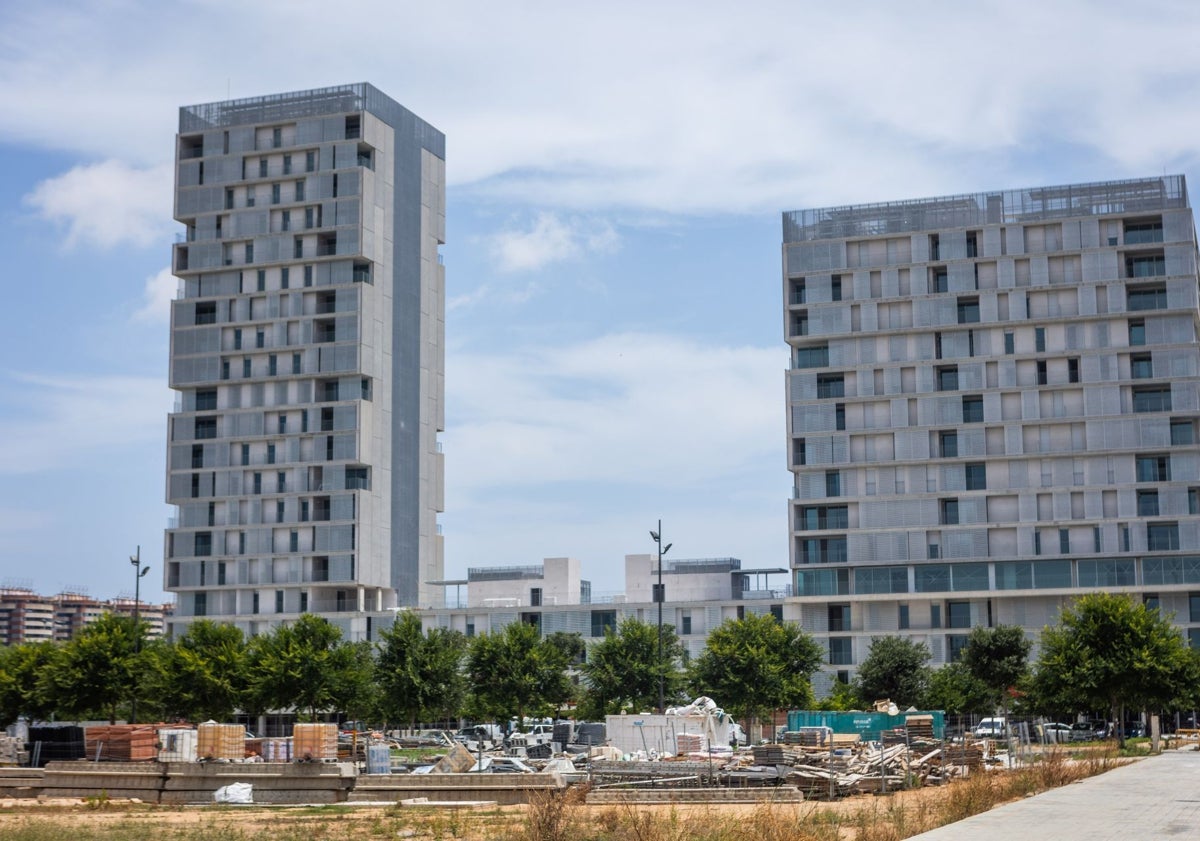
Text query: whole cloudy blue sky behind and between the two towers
0 0 1200 599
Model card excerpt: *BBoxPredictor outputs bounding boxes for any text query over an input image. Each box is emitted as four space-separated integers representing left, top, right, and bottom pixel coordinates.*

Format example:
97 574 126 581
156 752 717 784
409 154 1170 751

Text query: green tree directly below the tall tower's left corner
145 619 247 721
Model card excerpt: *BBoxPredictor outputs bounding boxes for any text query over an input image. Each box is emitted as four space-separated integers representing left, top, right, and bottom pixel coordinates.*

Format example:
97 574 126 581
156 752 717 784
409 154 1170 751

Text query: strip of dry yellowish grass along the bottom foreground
0 752 1122 841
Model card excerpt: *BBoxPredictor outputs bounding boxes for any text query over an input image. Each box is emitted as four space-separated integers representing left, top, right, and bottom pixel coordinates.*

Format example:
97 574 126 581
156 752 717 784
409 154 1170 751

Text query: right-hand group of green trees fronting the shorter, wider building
830 593 1200 743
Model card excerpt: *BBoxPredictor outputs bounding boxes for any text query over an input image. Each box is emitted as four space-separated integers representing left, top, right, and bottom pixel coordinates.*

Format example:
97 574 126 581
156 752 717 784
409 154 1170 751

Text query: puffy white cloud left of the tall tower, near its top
24 161 174 250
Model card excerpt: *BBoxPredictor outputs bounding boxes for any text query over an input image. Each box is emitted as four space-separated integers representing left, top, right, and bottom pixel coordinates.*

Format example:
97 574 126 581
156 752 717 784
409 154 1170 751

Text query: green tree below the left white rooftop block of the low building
467 621 571 721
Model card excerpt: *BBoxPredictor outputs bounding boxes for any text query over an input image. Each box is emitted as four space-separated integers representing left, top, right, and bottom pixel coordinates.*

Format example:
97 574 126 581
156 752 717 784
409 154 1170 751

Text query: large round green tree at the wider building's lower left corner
691 614 824 727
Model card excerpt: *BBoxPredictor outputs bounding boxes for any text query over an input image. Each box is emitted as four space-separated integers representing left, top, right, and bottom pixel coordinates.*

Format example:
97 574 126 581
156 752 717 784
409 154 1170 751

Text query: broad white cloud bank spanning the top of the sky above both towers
0 0 1200 213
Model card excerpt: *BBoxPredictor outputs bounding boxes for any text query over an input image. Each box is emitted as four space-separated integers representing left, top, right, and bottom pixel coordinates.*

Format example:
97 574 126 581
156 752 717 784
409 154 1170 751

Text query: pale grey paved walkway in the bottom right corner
911 751 1200 841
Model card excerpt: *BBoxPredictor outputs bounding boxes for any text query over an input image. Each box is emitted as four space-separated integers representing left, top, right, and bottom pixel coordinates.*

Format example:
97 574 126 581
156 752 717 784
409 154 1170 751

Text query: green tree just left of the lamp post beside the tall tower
37 613 145 723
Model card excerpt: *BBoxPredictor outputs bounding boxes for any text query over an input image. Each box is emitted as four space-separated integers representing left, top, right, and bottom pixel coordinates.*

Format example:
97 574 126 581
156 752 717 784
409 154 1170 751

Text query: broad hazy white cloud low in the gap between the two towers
445 334 787 493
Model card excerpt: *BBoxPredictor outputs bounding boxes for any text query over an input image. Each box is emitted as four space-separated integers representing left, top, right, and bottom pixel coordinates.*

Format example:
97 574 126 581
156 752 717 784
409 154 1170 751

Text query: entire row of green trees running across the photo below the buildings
0 594 1200 739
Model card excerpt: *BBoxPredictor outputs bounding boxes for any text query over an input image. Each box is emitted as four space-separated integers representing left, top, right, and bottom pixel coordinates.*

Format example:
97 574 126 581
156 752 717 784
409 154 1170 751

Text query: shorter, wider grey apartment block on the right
782 176 1200 689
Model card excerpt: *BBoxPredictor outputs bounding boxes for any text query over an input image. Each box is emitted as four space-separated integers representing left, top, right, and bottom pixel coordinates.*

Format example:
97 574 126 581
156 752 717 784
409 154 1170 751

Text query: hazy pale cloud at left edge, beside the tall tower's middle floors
0 374 172 475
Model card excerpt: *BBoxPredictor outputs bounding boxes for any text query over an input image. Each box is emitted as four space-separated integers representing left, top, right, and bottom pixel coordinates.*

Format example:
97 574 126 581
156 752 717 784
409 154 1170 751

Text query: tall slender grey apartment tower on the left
164 84 445 638
